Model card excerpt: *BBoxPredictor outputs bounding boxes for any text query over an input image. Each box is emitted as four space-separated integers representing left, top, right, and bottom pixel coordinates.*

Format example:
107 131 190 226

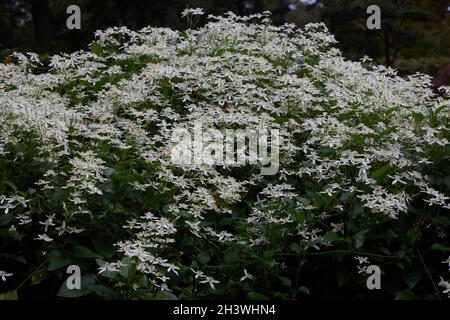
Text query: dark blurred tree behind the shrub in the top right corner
318 0 449 72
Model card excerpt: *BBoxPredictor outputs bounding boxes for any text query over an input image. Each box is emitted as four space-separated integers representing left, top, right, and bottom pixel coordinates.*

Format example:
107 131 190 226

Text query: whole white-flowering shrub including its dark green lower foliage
0 10 450 299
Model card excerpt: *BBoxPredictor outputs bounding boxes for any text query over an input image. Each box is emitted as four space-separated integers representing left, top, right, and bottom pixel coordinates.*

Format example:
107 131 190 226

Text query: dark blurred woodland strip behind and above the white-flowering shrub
0 0 450 75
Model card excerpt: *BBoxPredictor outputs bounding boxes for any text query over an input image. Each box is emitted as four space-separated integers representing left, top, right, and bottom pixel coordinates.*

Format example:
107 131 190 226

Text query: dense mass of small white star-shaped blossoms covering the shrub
0 9 450 298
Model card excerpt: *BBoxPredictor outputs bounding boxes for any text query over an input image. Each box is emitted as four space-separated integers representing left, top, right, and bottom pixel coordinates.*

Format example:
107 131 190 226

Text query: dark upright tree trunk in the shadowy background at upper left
31 0 50 52
